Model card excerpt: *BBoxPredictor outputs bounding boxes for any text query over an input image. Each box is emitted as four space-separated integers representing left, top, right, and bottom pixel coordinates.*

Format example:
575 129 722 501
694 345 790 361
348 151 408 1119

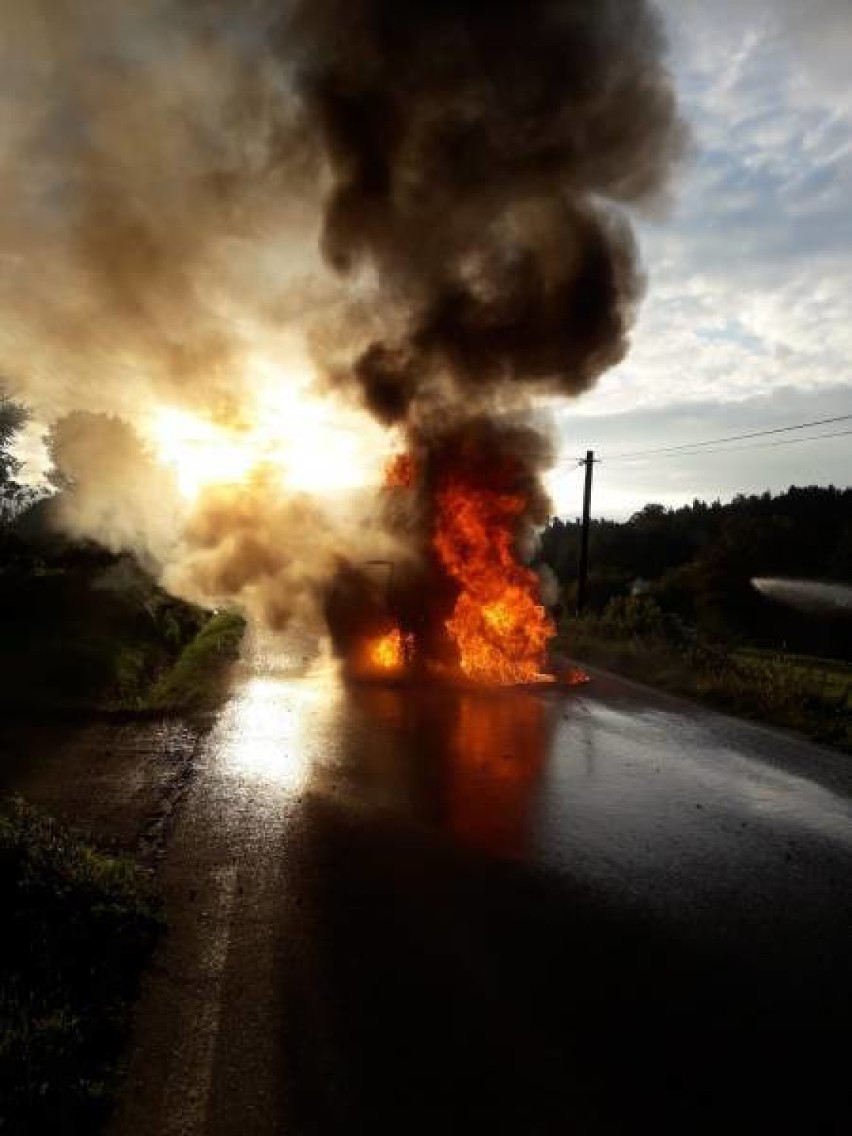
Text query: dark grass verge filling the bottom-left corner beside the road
0 802 159 1134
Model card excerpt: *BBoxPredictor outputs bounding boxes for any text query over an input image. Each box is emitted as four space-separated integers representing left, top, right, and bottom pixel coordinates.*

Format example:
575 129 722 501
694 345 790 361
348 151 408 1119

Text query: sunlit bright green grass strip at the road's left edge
145 611 245 712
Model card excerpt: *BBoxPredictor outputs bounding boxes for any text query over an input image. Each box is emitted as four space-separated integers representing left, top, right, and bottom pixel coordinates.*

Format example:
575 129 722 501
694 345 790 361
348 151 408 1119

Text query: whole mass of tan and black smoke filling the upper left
0 0 684 640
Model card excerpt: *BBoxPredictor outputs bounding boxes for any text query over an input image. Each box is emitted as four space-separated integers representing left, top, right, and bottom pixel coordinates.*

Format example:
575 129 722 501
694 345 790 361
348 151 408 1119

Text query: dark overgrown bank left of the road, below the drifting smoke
0 502 244 716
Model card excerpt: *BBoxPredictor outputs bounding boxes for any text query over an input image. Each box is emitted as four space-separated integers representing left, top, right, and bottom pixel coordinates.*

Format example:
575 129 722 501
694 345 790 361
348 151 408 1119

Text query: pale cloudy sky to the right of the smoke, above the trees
550 0 852 518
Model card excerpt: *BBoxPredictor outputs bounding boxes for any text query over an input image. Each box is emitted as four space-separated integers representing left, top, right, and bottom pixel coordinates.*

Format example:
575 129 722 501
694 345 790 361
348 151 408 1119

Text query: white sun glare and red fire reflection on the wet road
211 640 559 857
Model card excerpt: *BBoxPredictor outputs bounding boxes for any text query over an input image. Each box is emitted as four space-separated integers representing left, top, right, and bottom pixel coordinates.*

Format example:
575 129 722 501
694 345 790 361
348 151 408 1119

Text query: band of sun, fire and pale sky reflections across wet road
210 641 850 921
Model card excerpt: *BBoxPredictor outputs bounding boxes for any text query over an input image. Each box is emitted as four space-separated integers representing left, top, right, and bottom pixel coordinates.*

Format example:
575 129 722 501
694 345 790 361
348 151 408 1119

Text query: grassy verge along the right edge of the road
558 617 852 753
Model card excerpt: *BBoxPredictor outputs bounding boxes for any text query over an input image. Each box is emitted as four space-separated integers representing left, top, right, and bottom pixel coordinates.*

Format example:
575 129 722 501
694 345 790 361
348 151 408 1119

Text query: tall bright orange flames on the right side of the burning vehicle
434 478 556 684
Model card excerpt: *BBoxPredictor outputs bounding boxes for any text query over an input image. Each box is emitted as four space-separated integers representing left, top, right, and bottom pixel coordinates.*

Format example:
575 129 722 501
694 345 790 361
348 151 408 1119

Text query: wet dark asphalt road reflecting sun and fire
5 651 852 1136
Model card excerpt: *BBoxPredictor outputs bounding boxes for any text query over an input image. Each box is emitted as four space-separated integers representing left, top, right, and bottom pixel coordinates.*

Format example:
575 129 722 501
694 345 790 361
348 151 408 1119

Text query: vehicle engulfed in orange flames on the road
325 418 576 685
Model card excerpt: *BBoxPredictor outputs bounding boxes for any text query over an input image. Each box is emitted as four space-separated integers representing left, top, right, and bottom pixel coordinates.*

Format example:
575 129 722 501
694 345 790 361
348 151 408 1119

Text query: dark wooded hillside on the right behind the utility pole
538 486 852 658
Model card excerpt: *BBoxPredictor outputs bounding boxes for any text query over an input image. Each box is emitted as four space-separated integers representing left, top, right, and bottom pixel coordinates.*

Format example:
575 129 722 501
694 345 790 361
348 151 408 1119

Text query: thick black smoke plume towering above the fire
283 0 684 421
